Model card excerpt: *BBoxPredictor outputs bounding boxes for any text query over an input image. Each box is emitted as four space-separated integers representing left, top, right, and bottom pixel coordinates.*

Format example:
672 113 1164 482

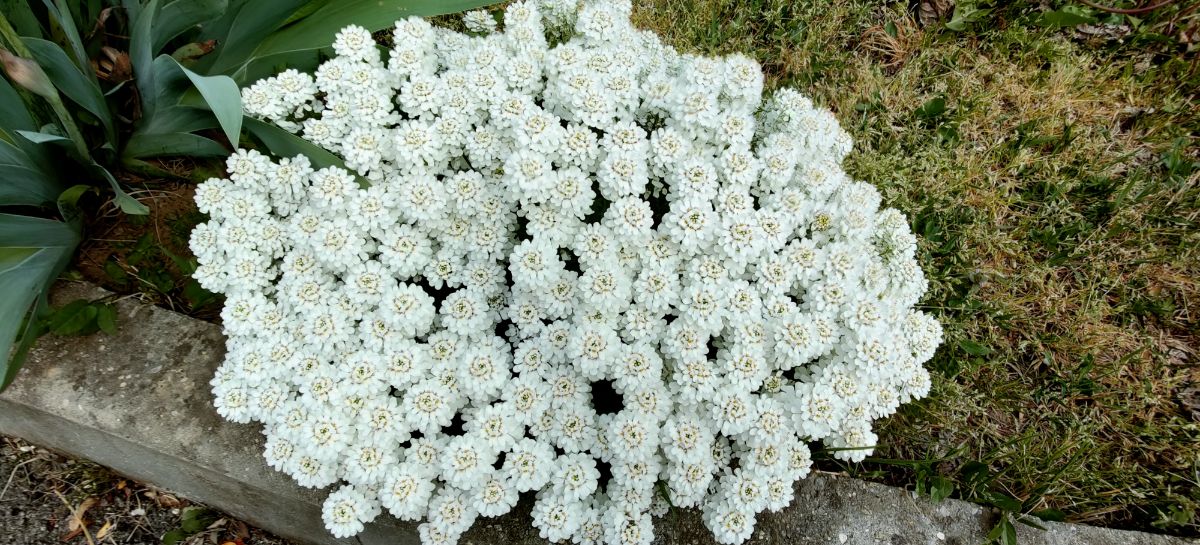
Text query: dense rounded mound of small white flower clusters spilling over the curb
192 0 941 544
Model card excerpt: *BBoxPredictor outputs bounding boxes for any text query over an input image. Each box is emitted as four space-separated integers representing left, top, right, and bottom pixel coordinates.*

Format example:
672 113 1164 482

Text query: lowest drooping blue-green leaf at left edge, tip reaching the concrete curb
0 214 79 390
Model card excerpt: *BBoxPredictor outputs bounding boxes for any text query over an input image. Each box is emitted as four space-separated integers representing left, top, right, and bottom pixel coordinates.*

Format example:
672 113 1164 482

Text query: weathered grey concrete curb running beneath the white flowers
0 283 1195 545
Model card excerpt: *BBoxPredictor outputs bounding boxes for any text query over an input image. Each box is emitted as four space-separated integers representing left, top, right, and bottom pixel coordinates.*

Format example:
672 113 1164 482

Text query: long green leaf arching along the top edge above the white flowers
231 0 496 82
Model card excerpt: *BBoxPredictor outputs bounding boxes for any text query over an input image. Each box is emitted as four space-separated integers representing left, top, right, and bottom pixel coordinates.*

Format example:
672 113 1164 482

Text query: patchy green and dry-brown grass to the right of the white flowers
635 0 1200 535
